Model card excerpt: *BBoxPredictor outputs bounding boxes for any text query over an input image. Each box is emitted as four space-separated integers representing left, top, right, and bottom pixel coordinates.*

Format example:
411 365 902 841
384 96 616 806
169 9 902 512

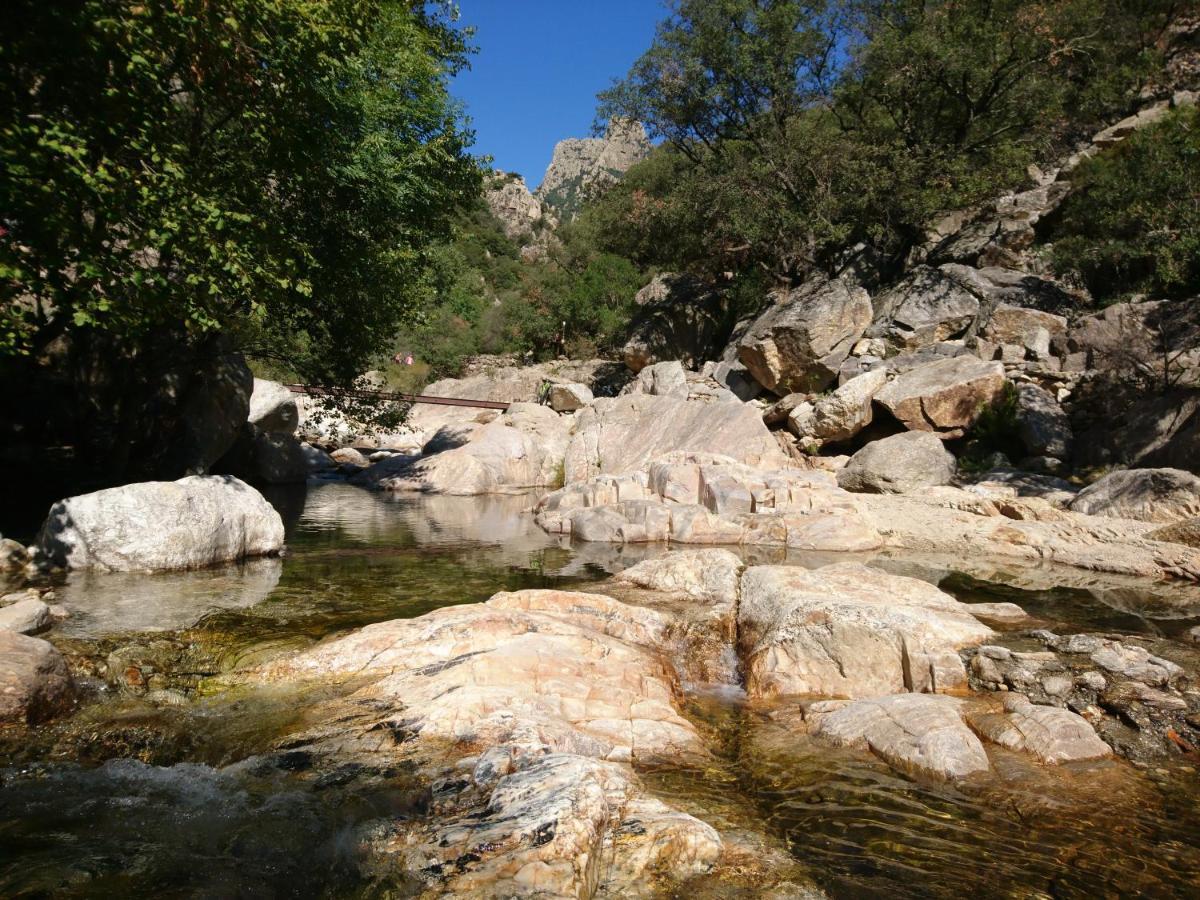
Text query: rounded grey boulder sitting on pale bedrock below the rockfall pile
838 431 958 493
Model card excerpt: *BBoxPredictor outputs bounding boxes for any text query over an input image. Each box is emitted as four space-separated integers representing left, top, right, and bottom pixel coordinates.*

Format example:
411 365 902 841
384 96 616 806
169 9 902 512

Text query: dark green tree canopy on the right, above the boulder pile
593 0 1178 281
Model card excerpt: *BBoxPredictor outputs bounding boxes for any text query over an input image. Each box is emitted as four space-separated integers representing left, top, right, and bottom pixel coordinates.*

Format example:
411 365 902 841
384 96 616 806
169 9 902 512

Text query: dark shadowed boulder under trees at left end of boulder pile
620 275 734 372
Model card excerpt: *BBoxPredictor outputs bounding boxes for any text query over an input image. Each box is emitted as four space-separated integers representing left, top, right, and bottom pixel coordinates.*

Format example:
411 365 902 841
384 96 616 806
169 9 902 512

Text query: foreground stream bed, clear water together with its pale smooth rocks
0 482 1200 896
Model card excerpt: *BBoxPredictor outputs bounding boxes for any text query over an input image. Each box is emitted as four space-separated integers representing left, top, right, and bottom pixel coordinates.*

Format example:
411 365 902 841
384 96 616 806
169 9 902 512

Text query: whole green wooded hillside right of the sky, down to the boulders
404 0 1200 381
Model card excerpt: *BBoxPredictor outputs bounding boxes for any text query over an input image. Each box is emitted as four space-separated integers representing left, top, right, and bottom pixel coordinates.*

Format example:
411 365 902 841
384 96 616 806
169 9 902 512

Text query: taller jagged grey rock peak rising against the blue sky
534 120 650 221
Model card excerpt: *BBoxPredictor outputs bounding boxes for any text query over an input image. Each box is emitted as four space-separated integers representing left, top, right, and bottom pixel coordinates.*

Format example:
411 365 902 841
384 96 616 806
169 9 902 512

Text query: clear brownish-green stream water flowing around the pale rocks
0 482 1200 898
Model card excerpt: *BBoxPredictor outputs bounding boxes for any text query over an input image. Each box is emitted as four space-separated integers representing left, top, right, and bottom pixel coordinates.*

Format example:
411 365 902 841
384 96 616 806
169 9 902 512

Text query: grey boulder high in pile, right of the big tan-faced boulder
872 266 979 350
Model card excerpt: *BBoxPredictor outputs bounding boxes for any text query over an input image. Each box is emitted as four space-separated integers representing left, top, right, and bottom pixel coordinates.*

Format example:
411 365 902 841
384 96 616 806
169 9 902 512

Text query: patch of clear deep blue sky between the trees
452 0 665 190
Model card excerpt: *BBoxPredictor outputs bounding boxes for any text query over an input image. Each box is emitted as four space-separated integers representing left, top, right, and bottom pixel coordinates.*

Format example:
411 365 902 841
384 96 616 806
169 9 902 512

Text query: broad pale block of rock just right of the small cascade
738 563 992 698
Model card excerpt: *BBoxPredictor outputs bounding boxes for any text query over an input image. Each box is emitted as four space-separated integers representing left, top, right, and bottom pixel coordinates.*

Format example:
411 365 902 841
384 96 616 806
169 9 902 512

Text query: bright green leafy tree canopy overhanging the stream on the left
0 0 479 380
